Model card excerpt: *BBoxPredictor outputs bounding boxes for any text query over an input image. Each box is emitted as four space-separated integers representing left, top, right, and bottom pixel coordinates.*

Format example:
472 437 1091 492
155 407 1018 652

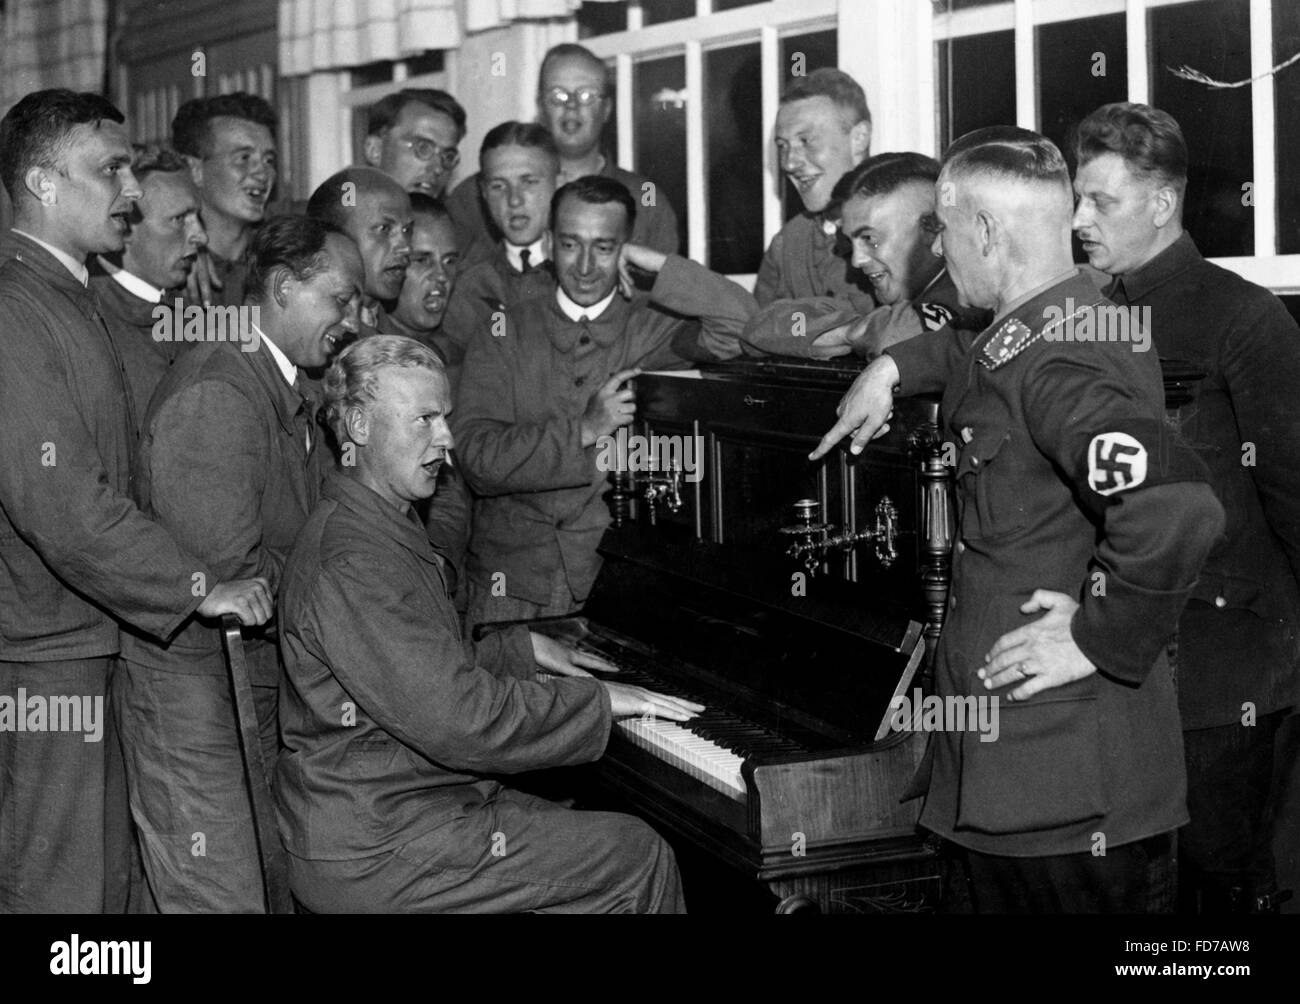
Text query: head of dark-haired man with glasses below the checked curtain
361 87 465 199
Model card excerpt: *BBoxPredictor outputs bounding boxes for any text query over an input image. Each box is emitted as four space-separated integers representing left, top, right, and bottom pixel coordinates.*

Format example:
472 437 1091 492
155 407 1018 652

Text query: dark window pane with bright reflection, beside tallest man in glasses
632 56 698 254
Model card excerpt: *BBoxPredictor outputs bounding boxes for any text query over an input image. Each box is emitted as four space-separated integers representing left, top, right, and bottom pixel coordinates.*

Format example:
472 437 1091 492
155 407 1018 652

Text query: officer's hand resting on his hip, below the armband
979 589 1097 701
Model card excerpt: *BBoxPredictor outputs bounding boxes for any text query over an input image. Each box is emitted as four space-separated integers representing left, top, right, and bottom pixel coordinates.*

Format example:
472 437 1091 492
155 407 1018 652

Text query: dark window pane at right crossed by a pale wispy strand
1149 0 1255 256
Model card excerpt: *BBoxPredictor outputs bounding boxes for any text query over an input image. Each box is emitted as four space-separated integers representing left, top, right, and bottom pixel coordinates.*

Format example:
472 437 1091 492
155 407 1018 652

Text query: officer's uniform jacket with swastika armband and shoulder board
887 274 1223 857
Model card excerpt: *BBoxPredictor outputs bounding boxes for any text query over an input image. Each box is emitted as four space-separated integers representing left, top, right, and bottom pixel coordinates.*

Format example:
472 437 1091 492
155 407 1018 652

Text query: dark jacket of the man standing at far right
1108 234 1300 728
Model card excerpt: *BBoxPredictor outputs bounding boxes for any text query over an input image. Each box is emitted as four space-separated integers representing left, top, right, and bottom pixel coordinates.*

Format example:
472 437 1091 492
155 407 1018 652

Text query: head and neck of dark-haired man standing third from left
172 91 280 307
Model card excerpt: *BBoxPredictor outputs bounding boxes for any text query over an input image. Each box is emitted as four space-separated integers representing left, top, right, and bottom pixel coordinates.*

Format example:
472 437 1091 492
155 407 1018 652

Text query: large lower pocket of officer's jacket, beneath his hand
957 696 1108 834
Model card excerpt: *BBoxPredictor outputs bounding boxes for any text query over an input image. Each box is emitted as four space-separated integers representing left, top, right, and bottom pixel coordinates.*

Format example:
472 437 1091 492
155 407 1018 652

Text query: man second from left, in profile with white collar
90 147 208 432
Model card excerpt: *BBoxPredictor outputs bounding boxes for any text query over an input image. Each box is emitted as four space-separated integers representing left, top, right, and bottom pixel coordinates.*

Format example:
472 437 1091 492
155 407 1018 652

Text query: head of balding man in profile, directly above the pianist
307 168 411 337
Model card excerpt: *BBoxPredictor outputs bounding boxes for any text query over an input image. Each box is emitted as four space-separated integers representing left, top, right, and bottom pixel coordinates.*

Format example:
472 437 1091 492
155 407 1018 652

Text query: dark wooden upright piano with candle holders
522 360 952 912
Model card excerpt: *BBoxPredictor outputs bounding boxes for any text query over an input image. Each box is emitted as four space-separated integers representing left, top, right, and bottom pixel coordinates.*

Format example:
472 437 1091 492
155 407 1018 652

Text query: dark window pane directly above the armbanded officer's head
1036 14 1128 163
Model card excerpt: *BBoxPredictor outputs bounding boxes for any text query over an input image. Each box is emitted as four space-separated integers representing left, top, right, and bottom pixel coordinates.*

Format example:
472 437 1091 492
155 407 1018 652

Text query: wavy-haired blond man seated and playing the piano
276 336 701 913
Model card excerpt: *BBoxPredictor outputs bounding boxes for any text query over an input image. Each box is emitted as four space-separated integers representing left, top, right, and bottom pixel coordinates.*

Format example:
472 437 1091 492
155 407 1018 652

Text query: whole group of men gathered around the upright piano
0 44 1300 913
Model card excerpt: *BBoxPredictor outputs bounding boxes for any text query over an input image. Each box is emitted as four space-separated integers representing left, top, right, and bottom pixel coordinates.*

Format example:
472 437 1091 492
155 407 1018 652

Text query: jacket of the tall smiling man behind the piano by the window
741 213 876 351
